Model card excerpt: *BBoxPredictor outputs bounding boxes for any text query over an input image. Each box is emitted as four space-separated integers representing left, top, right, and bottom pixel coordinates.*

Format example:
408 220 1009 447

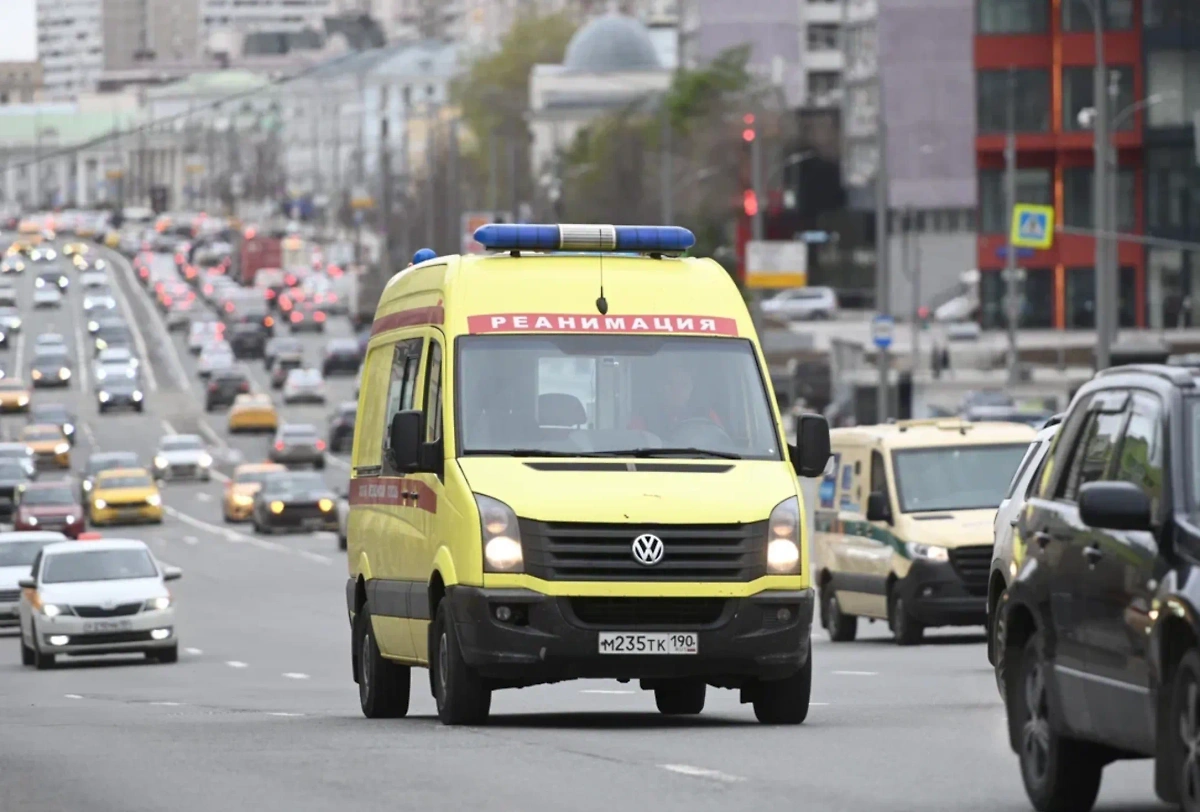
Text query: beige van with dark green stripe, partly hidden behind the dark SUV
812 419 1037 645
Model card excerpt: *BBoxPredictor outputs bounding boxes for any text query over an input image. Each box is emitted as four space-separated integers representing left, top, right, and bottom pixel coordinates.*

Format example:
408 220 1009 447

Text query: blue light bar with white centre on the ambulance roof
475 223 696 254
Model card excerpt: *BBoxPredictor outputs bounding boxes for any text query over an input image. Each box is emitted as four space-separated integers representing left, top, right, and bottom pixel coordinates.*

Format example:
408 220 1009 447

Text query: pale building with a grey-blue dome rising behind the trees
529 14 674 175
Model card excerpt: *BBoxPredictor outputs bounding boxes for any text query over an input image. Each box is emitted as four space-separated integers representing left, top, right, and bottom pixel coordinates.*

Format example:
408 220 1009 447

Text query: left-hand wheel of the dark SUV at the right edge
1004 632 1105 812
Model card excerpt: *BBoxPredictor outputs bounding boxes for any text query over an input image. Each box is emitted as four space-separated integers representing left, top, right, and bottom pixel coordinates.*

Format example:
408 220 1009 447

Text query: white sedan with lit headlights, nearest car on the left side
17 539 180 670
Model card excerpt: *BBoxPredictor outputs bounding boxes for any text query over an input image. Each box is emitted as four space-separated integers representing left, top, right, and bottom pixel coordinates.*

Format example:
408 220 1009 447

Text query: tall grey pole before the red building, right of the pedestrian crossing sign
1087 0 1112 369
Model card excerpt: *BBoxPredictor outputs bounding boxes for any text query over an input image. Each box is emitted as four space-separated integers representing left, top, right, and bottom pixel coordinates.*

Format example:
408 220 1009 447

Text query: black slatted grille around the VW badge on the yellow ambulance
520 519 767 582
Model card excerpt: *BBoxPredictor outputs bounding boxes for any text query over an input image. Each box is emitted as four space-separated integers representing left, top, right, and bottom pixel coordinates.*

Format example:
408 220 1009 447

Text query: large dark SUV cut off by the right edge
996 365 1200 811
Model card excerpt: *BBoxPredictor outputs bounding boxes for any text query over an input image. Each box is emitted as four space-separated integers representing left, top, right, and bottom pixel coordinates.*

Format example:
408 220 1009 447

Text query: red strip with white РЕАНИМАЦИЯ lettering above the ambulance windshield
467 313 738 336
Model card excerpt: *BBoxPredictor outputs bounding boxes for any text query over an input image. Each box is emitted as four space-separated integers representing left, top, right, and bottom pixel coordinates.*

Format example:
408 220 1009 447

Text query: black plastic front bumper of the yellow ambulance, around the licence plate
446 587 815 687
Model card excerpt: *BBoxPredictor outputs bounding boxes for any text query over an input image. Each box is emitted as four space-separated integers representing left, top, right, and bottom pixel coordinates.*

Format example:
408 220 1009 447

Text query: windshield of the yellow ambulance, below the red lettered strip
456 333 782 459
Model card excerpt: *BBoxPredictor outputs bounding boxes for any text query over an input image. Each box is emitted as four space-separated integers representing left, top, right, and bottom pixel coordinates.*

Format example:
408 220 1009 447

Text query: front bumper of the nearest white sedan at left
34 609 179 655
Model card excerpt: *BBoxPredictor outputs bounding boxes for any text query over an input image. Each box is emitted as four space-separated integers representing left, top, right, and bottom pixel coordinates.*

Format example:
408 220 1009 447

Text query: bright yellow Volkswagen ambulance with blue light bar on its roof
346 224 829 724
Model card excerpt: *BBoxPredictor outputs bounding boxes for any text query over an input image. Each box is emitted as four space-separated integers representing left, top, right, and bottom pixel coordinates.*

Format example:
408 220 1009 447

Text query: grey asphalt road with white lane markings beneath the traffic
0 237 1160 812
